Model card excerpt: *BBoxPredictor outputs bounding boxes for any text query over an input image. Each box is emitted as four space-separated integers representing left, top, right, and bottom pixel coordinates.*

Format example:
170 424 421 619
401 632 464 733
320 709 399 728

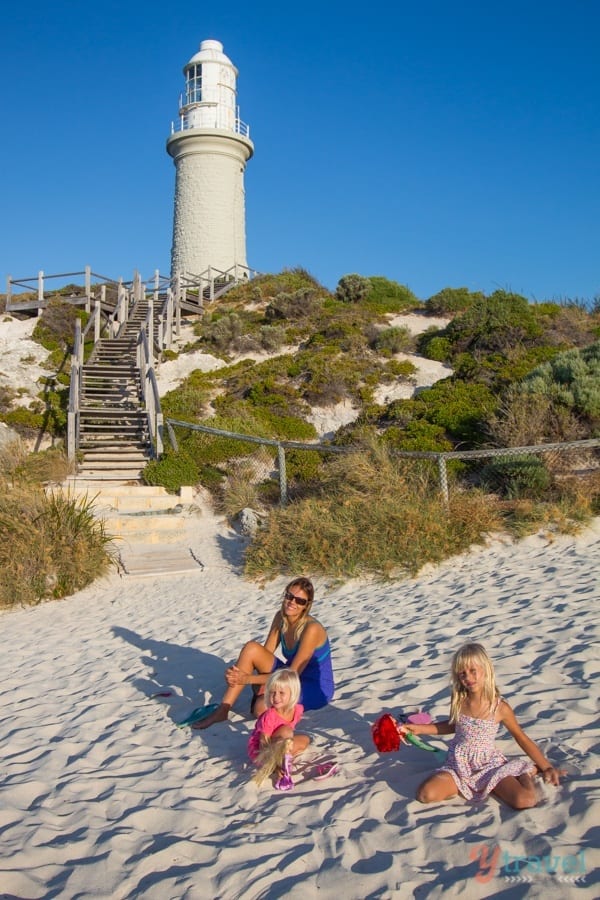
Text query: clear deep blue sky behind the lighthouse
0 0 600 301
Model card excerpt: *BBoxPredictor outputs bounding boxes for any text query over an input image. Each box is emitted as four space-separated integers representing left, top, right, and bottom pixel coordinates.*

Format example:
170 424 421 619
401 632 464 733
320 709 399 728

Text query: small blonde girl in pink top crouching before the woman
248 669 310 791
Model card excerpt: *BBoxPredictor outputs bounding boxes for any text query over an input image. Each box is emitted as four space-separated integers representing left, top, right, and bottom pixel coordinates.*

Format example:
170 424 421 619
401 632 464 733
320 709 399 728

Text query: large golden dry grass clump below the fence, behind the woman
246 445 501 577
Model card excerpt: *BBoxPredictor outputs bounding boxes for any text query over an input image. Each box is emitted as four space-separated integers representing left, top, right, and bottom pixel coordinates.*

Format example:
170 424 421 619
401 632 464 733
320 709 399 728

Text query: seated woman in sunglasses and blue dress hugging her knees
192 577 334 730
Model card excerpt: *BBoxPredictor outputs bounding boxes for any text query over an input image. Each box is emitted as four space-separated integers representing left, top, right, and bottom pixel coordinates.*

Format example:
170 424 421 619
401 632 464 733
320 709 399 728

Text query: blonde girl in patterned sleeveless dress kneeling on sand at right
399 644 563 809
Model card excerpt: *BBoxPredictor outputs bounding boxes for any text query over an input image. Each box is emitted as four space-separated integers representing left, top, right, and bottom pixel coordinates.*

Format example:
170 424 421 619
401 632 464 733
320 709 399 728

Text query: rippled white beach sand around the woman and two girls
0 514 600 900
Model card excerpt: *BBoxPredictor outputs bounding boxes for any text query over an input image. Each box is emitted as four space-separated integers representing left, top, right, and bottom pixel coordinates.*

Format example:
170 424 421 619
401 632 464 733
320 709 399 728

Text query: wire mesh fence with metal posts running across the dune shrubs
165 419 600 505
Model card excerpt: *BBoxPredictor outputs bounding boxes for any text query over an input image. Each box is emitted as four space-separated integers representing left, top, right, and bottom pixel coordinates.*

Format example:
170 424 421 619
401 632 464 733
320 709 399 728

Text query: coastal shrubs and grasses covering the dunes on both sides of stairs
0 269 600 603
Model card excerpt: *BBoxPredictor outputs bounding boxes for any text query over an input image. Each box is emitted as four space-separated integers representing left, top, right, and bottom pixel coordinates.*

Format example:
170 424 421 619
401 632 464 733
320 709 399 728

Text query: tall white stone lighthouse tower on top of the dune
167 40 254 278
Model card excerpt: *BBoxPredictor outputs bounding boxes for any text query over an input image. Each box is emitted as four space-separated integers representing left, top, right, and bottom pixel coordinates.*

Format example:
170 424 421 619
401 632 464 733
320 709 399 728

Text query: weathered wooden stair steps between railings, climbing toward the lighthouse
77 300 153 481
